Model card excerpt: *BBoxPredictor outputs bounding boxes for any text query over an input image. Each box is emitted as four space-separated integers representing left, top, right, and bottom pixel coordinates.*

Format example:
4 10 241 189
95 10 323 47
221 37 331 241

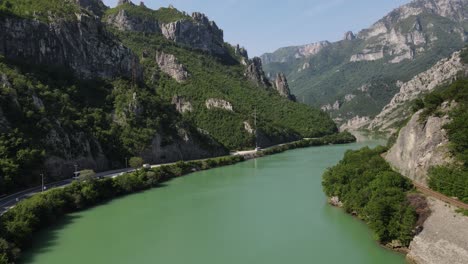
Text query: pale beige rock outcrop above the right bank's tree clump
385 106 453 186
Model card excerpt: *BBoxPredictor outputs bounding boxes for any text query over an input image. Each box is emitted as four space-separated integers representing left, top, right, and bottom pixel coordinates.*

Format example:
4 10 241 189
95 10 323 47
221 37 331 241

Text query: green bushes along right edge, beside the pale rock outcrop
414 78 468 202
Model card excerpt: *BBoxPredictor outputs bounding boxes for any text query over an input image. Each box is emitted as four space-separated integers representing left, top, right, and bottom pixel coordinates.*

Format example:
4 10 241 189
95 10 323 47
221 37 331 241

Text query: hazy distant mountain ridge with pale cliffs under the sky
261 0 468 124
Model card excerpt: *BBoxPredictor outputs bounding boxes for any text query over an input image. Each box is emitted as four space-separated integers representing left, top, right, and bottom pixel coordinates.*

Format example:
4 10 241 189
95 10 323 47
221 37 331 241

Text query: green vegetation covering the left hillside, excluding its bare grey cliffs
0 0 337 194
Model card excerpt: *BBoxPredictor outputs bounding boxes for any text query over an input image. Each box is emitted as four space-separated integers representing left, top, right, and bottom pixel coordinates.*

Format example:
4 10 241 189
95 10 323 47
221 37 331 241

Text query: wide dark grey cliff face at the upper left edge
0 13 142 80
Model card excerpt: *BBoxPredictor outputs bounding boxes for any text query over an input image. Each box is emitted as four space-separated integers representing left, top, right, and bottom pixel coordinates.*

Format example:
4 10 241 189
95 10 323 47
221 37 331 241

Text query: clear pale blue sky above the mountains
104 0 409 56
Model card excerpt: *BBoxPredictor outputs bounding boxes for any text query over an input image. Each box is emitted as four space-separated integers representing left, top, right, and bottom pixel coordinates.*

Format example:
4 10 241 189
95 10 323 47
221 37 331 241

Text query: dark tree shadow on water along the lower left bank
19 214 81 264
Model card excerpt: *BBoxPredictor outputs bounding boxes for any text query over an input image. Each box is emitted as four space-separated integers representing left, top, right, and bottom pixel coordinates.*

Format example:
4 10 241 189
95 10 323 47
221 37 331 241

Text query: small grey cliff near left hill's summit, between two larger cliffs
106 9 161 33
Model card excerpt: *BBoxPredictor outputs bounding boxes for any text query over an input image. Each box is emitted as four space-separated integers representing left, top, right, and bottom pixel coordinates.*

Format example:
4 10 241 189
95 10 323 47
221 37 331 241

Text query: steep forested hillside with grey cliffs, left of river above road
0 0 337 194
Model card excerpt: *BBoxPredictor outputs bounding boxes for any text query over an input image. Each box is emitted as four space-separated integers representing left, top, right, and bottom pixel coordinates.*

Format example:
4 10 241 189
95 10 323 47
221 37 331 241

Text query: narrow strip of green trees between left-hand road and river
0 134 354 263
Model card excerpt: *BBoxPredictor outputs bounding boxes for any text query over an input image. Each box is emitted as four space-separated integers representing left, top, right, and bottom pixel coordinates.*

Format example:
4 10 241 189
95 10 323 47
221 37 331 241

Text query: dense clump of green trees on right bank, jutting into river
323 147 418 246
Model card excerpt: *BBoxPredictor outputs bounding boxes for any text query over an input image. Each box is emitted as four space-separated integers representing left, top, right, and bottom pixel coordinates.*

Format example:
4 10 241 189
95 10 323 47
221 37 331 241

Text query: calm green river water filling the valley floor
24 144 405 264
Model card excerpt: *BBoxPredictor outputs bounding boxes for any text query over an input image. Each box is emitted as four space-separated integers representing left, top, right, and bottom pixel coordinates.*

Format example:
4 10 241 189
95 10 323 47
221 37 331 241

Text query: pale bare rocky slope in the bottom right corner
407 198 468 264
